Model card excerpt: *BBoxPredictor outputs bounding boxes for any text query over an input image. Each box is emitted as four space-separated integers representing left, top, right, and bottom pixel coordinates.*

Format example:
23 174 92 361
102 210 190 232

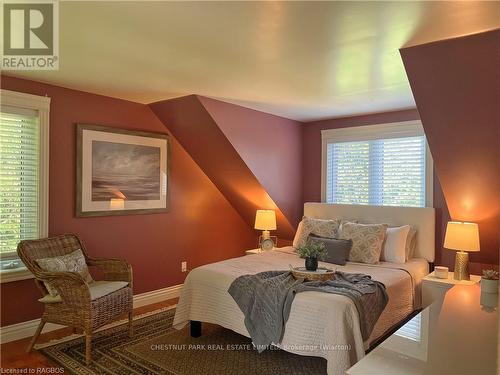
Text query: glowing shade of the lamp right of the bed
444 221 479 251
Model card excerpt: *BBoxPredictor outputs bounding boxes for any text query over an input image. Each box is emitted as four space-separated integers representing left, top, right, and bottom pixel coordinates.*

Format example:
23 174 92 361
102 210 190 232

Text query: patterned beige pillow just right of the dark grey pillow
339 222 387 264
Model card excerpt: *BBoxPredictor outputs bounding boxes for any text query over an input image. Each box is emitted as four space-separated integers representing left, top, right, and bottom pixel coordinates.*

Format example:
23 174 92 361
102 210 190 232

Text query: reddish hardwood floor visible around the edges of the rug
0 298 177 374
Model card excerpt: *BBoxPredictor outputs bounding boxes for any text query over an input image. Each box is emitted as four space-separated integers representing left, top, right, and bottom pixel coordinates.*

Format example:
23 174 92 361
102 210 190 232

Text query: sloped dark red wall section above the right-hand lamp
401 29 500 264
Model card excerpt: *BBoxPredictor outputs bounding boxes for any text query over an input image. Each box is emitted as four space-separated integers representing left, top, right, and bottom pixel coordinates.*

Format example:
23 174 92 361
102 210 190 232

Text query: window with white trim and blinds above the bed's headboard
322 121 432 207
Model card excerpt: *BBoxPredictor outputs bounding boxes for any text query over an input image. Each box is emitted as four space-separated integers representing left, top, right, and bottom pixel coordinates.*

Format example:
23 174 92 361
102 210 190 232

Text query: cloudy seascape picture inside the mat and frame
92 141 161 201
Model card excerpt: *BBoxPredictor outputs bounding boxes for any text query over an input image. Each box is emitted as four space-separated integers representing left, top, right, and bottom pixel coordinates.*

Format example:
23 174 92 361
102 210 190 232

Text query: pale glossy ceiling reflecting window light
6 1 500 120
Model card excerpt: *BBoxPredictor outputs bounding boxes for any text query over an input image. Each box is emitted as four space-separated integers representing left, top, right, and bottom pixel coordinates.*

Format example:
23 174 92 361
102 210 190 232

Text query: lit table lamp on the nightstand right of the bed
444 221 479 280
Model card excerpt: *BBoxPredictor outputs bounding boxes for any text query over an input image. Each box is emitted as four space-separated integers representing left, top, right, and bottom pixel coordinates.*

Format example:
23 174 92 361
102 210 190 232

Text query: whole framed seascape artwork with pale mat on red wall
76 124 170 217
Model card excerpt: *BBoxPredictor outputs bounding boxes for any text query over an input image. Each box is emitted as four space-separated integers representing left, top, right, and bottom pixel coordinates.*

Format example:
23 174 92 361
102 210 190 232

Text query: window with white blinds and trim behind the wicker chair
0 90 50 282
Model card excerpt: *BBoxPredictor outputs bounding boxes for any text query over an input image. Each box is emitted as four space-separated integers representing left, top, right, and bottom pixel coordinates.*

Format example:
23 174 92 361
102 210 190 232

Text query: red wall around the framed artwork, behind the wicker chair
1 76 258 326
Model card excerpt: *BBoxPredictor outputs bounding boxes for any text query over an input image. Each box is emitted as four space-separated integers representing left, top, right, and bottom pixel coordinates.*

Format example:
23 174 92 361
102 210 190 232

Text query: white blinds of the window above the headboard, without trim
326 136 426 207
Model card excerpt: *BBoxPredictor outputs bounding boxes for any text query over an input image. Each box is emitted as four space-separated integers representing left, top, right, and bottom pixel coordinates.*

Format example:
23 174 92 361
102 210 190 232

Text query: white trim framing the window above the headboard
321 120 434 207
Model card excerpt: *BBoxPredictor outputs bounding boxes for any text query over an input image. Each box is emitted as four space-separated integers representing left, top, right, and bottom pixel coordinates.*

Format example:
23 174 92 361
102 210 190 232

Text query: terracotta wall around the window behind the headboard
302 109 460 268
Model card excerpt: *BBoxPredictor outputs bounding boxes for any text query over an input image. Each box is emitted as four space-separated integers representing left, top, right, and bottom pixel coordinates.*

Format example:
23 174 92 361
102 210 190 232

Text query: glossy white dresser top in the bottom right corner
347 284 498 375
